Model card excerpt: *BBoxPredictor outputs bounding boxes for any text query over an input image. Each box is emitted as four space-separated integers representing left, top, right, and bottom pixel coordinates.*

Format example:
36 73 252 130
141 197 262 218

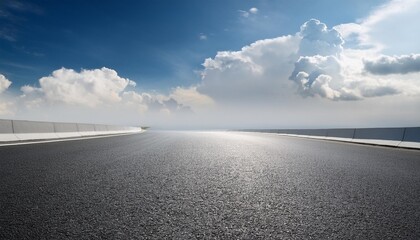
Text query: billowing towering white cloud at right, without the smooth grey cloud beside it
289 19 420 100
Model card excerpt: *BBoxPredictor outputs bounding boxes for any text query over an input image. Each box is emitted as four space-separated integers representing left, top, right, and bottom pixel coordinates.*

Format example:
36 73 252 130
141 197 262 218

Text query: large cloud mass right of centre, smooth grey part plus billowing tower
197 19 414 104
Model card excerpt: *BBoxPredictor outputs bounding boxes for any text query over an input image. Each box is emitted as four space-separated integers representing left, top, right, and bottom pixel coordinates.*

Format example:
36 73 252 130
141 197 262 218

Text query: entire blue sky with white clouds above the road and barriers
0 0 420 129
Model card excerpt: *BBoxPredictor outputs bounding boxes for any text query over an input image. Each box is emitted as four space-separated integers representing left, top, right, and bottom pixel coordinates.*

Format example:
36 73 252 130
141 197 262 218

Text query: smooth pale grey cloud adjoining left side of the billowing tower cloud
197 36 300 103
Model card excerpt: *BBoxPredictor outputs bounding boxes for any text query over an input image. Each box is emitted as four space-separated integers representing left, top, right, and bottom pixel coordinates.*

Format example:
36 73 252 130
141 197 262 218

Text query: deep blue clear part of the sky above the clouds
0 0 383 91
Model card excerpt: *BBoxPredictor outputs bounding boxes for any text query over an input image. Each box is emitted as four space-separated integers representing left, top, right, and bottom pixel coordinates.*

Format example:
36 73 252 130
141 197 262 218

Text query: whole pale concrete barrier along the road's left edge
0 119 141 142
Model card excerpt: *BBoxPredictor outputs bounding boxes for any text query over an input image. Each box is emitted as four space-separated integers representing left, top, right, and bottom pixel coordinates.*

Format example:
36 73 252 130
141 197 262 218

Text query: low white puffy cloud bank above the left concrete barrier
11 67 203 124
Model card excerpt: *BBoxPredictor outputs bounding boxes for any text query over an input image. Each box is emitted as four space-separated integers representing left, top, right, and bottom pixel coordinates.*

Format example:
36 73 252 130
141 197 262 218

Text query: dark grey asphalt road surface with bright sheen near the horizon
0 131 420 239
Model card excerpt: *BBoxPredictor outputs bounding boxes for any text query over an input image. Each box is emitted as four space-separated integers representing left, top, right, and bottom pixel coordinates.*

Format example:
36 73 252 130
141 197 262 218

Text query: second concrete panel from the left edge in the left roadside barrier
12 120 58 140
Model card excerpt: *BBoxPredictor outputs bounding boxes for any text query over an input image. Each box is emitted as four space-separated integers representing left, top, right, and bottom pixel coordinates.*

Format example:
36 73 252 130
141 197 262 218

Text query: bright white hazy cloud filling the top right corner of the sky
335 0 420 55
